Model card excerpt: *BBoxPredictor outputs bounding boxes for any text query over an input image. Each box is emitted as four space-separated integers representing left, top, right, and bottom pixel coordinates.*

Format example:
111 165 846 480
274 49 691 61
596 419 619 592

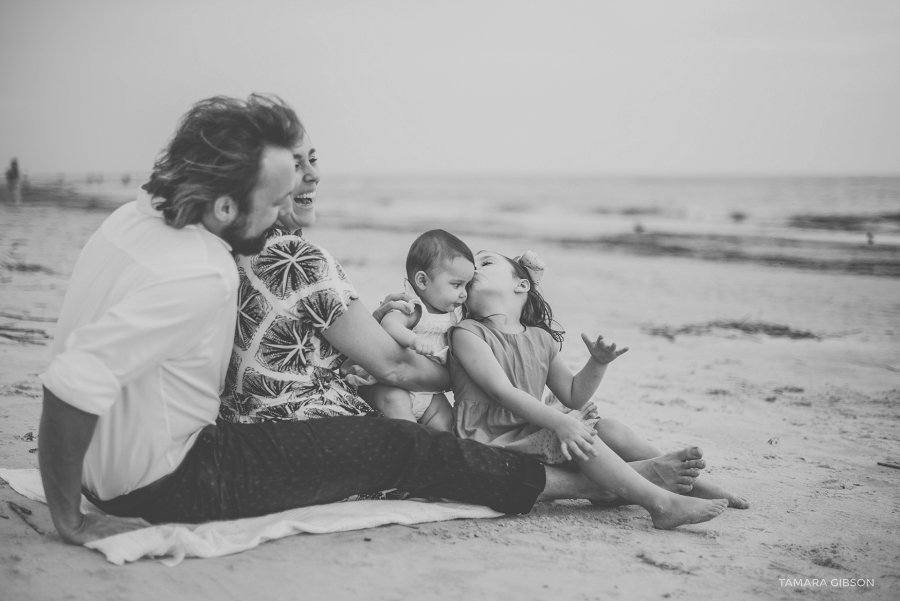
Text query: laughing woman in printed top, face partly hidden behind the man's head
220 125 448 423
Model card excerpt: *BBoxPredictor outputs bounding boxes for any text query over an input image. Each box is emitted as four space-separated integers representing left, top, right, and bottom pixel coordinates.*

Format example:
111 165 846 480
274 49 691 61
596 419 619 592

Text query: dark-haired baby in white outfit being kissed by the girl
359 230 475 431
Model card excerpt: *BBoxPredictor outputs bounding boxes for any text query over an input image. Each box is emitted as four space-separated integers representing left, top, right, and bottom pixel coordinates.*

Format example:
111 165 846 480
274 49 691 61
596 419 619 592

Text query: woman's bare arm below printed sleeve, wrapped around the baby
322 300 450 391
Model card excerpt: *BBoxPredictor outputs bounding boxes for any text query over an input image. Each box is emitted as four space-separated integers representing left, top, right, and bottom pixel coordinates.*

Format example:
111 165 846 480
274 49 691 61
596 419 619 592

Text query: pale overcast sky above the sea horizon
0 0 900 176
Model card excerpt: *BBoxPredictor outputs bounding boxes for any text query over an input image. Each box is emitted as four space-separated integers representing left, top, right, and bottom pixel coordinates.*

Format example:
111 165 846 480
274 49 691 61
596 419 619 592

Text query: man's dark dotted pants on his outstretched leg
92 417 546 523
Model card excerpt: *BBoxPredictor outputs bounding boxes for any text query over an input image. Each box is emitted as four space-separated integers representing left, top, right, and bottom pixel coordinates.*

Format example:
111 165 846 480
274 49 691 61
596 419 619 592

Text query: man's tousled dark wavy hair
143 94 304 228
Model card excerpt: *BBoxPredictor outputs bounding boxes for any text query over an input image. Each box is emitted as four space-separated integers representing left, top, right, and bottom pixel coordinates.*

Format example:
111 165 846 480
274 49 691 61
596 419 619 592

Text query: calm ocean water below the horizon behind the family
24 173 900 245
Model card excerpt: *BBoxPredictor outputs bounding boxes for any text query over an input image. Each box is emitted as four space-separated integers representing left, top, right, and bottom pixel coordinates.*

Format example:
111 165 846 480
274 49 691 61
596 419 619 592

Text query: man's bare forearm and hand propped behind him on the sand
38 387 150 545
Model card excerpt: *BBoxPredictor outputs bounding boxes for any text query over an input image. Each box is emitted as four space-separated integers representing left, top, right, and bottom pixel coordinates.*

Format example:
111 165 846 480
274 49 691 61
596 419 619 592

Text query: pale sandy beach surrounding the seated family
0 191 900 601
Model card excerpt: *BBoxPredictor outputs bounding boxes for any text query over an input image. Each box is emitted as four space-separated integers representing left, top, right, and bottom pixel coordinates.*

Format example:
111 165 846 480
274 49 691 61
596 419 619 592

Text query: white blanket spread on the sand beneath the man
0 469 503 566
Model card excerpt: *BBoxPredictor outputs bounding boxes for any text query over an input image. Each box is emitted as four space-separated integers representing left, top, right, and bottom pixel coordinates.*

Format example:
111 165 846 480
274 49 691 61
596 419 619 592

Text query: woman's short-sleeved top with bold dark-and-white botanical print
220 228 375 423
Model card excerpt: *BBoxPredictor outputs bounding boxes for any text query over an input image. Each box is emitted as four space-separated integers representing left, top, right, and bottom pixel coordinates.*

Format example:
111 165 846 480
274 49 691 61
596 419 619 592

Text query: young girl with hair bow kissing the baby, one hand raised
449 251 729 528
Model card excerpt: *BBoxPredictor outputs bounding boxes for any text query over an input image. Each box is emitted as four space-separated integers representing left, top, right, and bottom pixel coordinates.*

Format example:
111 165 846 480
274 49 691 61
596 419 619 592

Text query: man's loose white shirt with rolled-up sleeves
41 191 238 500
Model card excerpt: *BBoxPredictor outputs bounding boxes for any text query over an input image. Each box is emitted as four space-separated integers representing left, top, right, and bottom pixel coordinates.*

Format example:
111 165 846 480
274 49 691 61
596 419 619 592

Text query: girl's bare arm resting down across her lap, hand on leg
450 329 597 460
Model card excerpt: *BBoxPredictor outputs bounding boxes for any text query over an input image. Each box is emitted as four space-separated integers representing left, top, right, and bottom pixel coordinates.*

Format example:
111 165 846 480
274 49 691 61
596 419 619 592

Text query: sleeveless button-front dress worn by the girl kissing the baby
448 319 597 465
